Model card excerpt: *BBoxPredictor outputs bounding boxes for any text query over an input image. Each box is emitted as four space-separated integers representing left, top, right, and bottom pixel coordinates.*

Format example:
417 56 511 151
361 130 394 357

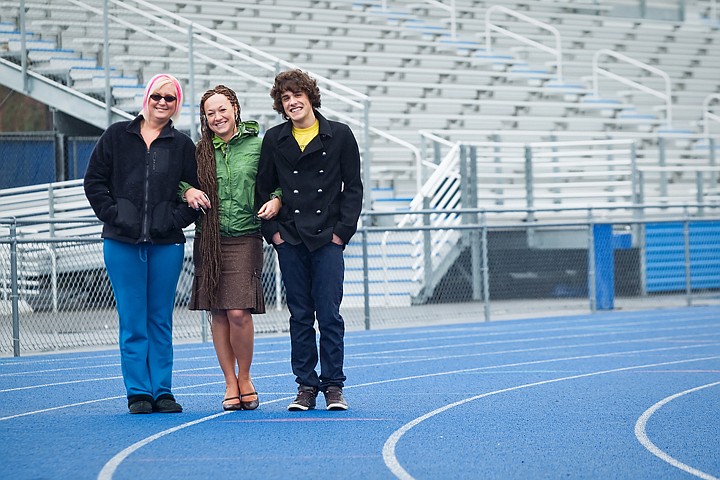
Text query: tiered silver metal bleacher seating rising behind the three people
0 0 720 308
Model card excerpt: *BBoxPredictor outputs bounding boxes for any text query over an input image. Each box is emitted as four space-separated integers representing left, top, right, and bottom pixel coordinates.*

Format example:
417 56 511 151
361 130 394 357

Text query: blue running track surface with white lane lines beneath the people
0 306 720 479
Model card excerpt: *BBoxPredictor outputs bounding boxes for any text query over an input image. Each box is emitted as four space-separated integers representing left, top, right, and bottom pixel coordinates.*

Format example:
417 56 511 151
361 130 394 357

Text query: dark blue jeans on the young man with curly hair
275 242 346 391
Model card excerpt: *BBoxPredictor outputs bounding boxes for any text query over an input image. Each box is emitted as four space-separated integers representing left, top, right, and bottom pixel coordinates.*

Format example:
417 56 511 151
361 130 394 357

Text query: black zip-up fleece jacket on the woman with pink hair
84 115 198 244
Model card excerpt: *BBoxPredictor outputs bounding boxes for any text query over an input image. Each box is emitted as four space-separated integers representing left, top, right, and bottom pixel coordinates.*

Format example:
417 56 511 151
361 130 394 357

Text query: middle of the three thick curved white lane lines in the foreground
378 352 720 480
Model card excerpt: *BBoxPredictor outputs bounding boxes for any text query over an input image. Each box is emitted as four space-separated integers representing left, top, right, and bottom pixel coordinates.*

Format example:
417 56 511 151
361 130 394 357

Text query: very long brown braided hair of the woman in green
195 85 240 307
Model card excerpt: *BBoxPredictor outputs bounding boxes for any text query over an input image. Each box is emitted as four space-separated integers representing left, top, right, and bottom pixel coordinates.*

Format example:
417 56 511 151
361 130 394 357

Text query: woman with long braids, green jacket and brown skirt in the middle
184 85 281 410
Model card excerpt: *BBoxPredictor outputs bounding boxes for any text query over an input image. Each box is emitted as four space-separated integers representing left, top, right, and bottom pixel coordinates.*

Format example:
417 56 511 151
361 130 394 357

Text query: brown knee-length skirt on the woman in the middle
188 234 265 313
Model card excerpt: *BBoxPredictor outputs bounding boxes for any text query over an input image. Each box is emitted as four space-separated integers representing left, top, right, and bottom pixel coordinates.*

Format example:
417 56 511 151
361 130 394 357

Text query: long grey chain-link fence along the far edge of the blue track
5 206 720 355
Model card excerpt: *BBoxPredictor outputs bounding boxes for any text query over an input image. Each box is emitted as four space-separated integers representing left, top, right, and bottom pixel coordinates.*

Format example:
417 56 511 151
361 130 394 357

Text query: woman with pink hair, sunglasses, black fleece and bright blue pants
84 73 198 413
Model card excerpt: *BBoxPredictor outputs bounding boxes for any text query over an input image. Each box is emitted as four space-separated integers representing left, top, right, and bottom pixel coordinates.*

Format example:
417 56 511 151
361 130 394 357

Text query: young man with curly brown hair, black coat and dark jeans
256 70 363 410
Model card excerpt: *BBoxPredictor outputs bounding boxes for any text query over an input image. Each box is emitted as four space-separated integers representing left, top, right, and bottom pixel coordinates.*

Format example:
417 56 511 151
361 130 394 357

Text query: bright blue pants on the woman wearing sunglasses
103 239 184 403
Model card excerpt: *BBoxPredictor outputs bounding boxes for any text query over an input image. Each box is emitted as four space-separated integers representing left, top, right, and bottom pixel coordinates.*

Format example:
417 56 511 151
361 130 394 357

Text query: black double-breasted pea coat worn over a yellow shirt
256 110 363 251
